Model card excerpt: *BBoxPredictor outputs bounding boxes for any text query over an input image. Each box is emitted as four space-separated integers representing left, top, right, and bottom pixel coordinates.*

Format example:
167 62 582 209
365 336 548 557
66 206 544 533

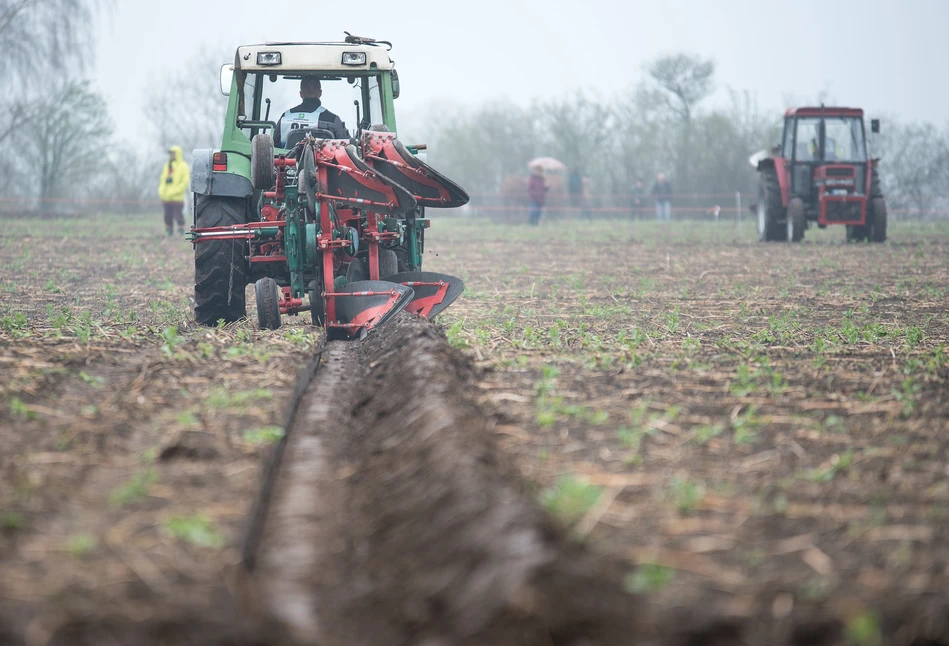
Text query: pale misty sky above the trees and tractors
92 0 949 139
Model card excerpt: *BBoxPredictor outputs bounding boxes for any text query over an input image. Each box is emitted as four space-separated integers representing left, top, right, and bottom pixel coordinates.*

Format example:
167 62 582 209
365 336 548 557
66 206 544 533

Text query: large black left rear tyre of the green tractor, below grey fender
194 195 247 325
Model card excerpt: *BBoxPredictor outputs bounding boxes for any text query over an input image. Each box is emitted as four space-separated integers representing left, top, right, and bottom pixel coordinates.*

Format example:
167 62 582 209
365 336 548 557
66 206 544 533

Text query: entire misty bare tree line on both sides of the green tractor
0 0 949 216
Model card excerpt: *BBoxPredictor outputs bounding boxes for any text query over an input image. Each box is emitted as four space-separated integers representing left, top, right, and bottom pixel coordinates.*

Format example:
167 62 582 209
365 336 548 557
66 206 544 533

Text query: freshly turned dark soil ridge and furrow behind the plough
250 316 636 646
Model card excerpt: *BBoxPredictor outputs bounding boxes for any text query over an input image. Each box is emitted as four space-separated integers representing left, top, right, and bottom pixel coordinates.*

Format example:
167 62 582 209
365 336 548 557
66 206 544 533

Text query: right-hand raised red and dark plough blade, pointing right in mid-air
362 130 468 208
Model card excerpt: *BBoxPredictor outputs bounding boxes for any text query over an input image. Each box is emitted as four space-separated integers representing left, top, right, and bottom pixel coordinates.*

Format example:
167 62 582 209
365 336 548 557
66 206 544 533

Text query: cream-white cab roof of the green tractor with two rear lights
236 43 393 74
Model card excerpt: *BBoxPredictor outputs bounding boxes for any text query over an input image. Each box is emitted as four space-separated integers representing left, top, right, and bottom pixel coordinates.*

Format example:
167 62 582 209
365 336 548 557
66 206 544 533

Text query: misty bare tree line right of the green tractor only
418 53 949 217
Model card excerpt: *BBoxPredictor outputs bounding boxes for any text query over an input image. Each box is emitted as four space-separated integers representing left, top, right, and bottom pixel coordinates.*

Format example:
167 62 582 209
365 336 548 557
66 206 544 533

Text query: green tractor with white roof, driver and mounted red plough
188 34 468 338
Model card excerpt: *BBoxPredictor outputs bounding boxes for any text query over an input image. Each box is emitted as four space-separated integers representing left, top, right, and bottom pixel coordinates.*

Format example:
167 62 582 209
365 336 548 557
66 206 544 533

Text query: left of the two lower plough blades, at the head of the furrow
324 280 415 339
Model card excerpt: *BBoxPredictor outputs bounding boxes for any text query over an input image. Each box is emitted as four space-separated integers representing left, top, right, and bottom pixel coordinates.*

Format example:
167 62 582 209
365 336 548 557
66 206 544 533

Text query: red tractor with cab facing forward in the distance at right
751 106 886 242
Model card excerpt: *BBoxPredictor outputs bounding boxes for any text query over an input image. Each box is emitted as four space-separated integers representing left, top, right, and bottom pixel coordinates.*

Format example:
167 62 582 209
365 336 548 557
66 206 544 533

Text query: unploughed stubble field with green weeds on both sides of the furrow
0 217 949 645
